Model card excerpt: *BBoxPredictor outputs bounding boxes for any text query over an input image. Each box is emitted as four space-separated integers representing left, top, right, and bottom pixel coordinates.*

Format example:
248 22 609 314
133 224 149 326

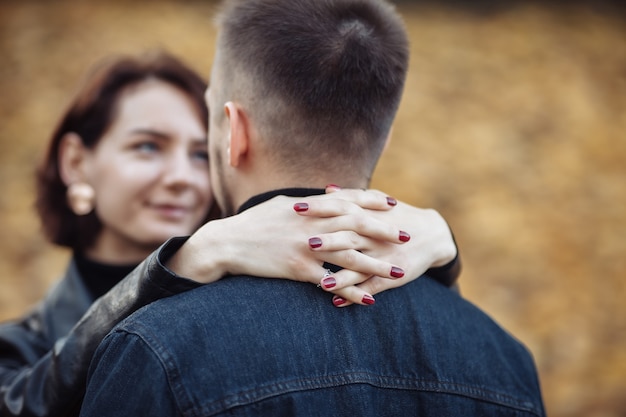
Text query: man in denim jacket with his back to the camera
81 0 544 416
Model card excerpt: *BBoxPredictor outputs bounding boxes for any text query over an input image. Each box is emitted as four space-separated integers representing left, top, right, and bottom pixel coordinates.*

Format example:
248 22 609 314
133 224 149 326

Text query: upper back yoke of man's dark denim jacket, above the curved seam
106 276 541 414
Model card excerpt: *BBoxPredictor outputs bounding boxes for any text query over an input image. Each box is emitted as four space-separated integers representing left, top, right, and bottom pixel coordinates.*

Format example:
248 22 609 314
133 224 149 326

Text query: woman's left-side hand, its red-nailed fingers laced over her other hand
167 190 409 302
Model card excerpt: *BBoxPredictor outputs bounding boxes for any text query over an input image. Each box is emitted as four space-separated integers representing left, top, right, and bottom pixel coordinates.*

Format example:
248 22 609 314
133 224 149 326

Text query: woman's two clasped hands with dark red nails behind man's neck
167 186 456 306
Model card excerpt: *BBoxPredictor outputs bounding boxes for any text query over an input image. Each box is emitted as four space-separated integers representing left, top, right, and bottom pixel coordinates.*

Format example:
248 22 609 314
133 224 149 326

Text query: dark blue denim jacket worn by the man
81 190 545 417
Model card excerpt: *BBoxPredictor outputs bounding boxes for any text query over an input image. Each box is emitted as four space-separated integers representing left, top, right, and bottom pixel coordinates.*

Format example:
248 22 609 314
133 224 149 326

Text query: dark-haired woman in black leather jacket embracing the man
0 50 458 416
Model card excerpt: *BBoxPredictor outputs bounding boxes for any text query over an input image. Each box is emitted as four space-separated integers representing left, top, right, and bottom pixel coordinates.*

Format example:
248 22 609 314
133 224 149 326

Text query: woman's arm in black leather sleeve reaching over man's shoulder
0 239 200 417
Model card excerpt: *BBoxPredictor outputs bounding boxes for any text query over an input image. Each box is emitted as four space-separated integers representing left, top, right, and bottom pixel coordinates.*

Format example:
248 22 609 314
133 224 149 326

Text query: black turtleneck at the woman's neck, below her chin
74 252 137 299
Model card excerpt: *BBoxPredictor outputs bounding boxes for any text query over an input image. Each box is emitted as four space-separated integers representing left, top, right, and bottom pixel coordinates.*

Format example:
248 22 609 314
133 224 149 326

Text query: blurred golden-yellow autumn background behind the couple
0 0 626 417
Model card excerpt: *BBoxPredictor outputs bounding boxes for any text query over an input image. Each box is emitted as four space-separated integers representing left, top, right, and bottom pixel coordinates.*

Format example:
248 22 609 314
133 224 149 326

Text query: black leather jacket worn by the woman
0 239 200 416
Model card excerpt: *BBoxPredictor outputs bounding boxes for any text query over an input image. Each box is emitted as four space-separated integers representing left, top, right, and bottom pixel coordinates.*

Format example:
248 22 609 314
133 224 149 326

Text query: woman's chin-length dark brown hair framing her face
35 51 208 249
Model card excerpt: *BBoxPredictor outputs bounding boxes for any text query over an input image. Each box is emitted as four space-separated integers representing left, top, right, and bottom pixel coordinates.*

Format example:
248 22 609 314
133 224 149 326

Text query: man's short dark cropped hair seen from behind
214 0 409 176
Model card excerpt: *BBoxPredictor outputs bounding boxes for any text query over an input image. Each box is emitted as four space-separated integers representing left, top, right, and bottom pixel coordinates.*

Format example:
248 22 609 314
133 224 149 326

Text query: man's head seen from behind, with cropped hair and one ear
209 0 408 213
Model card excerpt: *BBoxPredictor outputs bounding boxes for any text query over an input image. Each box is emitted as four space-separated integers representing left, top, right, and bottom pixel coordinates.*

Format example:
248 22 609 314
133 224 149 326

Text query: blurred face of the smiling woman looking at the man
84 80 213 262
